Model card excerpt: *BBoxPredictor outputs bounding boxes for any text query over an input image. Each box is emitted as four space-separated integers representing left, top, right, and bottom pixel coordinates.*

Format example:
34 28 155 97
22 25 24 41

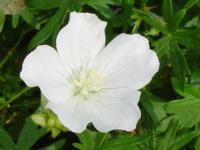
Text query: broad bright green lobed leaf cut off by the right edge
165 98 200 128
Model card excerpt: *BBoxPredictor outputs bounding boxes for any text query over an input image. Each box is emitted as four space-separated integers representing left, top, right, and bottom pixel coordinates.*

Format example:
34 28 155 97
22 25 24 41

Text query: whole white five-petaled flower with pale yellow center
20 12 159 132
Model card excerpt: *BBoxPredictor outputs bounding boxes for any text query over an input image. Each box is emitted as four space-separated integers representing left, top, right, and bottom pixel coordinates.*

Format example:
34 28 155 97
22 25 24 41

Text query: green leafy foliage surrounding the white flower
0 0 200 150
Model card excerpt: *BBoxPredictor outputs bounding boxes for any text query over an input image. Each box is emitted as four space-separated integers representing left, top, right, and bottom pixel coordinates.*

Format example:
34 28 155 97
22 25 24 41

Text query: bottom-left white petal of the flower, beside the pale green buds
47 97 93 133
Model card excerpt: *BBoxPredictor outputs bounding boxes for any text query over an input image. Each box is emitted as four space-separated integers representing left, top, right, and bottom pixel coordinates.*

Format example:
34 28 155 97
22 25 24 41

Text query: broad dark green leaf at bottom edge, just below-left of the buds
17 119 47 150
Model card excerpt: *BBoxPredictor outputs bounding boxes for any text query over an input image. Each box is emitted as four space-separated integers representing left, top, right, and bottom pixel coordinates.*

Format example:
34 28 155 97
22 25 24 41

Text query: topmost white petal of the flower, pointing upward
56 12 106 71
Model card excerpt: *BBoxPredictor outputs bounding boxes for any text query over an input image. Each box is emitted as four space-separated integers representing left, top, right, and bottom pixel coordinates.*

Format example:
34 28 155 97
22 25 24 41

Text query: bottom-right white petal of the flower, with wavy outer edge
91 89 141 132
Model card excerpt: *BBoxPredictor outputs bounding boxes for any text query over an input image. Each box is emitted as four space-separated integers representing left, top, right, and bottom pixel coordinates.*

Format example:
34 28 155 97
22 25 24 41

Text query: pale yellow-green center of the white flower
73 70 102 99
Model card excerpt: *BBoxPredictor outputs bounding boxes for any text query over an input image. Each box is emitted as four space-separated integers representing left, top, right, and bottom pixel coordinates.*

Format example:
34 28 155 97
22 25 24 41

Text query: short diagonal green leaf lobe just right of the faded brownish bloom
20 7 40 30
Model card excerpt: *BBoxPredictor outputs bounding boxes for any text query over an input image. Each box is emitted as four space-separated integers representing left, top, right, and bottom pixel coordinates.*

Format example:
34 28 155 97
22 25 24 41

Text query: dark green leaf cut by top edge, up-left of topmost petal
27 0 63 10
